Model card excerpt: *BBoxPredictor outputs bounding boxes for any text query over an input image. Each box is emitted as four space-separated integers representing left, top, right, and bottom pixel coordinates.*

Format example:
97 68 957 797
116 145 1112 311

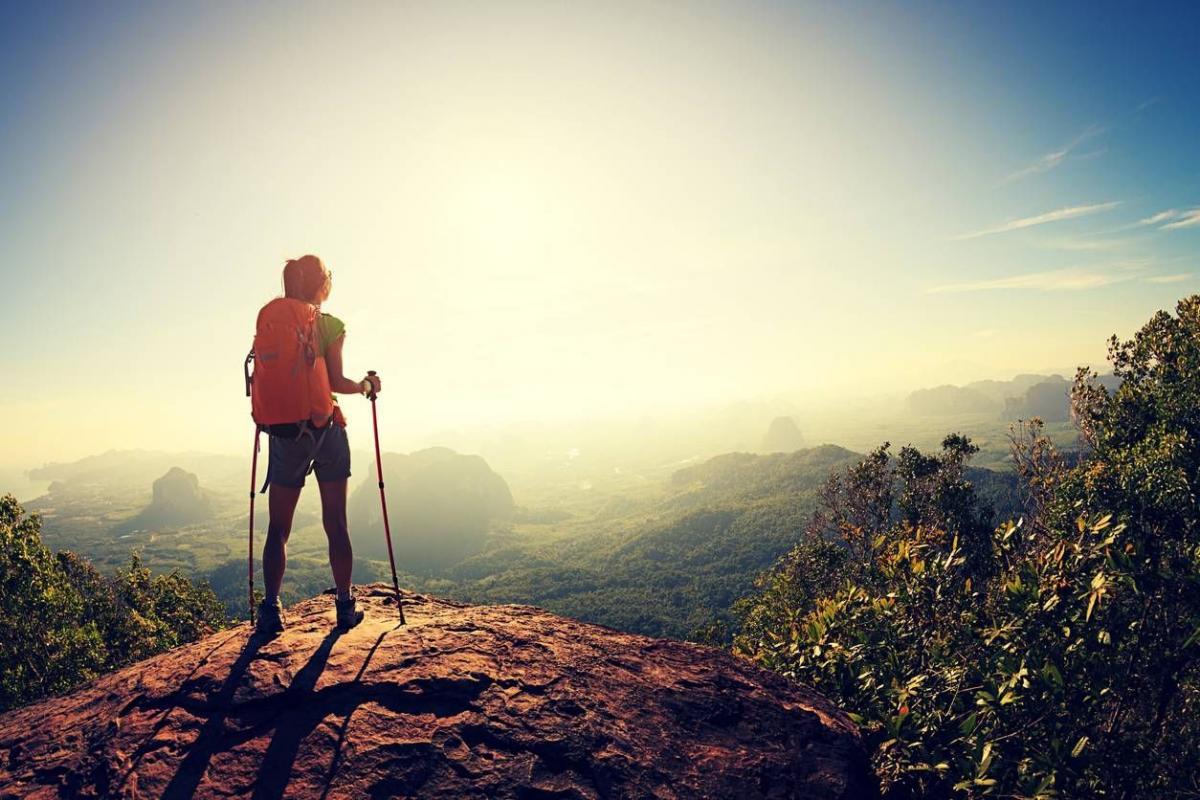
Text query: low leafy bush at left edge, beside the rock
0 495 228 711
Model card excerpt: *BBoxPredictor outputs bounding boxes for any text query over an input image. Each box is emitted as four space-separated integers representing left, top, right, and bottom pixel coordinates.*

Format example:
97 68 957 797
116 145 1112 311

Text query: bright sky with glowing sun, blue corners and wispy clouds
0 1 1200 467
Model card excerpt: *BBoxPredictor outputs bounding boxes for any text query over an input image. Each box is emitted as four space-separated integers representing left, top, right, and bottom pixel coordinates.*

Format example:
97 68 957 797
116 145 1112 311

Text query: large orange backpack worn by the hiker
246 297 334 427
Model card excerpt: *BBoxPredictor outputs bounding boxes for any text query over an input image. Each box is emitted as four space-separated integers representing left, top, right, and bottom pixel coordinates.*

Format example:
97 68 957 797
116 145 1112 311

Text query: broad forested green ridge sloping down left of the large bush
448 445 860 638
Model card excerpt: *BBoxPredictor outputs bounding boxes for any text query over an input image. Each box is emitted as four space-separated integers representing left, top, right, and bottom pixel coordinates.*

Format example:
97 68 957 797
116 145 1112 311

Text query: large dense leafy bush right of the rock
734 297 1200 798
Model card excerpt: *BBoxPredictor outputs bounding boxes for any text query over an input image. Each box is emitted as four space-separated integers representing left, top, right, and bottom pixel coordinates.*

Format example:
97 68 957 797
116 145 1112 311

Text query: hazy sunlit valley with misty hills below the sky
4 373 1076 636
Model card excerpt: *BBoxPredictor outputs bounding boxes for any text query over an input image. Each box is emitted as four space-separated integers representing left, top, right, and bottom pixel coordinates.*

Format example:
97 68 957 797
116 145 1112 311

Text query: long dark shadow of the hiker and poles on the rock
162 628 390 800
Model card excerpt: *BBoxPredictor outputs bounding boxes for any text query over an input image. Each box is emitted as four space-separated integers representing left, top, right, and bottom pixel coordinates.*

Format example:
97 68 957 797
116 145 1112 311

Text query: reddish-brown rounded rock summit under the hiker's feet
0 585 875 799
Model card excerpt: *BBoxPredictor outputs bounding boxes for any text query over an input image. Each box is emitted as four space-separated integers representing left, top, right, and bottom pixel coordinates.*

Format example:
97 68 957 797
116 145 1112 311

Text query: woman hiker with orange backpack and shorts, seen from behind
247 255 380 636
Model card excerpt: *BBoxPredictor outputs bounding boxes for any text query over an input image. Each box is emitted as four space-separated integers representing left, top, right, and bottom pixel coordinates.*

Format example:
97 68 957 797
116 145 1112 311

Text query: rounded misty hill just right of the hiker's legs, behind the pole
348 447 515 575
